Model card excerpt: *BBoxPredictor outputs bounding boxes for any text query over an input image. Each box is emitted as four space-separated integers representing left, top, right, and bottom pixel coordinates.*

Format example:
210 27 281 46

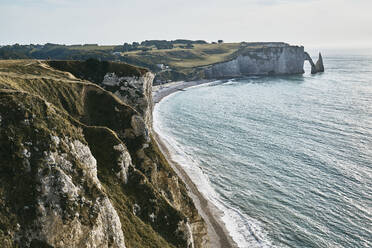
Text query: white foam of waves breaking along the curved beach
154 91 273 248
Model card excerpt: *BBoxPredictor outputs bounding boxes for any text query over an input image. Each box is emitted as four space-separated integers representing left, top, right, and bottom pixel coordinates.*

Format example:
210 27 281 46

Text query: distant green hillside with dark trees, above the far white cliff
0 40 296 83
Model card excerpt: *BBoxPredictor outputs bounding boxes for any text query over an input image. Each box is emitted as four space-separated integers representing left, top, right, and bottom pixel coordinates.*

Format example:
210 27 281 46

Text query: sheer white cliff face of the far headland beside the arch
204 44 305 78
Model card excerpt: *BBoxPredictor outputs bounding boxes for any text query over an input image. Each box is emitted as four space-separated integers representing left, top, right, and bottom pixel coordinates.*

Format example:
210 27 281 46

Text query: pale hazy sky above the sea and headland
0 0 372 48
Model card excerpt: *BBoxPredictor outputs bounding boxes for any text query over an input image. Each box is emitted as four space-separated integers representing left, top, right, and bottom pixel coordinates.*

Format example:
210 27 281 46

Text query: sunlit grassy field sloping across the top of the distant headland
117 43 274 81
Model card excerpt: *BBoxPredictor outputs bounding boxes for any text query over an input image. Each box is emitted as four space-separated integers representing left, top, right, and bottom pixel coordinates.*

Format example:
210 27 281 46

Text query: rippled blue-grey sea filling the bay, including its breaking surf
154 55 372 247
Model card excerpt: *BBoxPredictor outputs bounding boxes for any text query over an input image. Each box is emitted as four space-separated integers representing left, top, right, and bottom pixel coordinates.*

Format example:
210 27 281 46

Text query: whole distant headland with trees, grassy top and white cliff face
0 40 324 85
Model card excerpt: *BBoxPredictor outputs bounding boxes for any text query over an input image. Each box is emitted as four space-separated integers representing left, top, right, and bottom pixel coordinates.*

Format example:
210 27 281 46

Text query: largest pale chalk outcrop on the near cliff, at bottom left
17 137 125 248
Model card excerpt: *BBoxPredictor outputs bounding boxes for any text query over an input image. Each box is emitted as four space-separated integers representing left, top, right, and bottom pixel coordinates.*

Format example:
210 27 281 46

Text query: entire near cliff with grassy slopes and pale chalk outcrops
0 60 208 248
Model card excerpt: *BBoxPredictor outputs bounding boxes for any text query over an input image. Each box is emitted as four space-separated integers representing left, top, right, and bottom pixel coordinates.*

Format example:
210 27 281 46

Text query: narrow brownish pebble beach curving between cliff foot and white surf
153 80 238 248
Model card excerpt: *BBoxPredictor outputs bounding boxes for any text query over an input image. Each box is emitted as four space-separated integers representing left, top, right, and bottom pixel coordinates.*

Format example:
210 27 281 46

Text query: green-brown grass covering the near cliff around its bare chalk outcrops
0 60 205 248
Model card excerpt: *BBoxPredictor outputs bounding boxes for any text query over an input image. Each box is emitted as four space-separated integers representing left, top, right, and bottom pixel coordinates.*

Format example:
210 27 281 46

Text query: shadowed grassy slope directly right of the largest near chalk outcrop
84 127 182 248
